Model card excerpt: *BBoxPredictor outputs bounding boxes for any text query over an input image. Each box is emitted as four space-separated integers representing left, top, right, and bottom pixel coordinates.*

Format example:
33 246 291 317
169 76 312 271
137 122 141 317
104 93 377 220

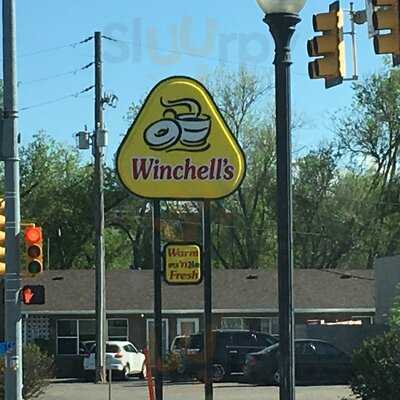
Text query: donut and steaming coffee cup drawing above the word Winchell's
144 97 211 152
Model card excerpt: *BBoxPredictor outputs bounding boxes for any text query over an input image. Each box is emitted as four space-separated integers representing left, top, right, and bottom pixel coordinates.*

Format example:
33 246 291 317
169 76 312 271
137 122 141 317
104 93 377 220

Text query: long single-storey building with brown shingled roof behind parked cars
0 269 375 376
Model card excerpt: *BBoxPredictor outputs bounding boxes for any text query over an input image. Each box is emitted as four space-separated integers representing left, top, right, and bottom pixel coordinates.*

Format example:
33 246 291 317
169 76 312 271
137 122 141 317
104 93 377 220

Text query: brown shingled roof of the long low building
19 269 375 313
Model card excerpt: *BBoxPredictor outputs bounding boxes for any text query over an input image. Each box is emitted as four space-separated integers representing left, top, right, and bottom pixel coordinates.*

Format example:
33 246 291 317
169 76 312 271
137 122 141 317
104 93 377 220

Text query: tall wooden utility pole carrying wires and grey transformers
92 32 107 383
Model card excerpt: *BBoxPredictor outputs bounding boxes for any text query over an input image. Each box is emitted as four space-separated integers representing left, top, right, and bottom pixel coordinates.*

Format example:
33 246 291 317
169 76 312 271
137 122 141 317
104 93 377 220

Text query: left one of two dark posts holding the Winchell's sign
153 200 163 400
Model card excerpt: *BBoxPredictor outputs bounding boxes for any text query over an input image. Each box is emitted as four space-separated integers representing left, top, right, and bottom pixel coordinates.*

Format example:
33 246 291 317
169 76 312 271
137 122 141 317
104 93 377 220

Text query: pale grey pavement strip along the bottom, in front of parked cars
39 379 350 400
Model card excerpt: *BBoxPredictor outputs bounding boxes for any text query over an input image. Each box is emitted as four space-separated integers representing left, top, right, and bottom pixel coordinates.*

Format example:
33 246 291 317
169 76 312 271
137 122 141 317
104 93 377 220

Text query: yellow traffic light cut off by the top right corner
372 0 400 65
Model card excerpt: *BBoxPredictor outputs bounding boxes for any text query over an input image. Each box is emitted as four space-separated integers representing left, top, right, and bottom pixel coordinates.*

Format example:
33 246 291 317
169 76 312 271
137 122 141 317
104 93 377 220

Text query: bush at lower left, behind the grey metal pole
0 344 55 400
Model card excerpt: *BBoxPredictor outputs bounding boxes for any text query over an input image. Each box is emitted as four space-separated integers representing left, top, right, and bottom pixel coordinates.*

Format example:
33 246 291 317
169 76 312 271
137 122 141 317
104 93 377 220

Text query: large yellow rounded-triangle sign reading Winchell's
117 77 245 199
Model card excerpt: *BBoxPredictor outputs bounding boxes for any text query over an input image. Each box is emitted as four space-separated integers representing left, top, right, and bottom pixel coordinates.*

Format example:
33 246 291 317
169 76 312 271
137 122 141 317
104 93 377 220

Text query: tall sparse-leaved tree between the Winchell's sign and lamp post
202 69 276 269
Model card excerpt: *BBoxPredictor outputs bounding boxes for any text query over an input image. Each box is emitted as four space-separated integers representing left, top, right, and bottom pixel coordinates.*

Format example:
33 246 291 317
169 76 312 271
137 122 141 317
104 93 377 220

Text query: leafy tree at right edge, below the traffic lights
336 67 400 267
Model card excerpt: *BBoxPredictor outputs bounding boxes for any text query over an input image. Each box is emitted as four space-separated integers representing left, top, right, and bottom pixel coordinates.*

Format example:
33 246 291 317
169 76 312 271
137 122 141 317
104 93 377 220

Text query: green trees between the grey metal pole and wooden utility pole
21 132 93 269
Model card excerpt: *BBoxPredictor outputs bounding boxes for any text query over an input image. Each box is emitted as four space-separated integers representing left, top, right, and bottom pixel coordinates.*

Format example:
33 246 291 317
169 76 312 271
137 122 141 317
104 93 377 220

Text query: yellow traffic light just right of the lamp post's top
307 1 346 88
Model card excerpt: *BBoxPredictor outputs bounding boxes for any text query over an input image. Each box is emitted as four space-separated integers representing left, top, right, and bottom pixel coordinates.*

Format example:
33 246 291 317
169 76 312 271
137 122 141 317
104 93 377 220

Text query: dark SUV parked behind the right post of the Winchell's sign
183 329 277 382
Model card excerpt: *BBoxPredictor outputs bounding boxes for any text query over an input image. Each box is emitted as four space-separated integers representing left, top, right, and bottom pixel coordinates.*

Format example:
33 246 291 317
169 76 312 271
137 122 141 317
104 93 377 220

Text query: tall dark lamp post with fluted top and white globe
257 0 306 400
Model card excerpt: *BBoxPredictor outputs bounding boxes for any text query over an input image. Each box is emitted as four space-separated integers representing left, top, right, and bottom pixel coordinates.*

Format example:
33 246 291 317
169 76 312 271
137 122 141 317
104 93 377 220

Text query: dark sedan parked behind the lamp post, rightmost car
244 339 351 385
